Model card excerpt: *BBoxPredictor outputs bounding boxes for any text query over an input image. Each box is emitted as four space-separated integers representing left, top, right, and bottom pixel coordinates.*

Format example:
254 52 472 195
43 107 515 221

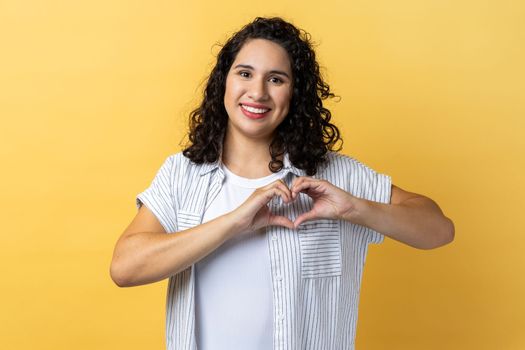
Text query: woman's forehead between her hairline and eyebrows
232 39 291 72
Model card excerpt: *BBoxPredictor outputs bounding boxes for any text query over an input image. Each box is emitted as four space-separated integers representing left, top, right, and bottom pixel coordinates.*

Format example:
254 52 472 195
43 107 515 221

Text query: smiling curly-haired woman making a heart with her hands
111 18 454 349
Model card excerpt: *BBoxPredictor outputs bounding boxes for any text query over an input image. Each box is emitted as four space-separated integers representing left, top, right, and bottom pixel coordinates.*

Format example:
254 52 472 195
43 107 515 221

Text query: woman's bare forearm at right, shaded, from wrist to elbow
344 196 454 249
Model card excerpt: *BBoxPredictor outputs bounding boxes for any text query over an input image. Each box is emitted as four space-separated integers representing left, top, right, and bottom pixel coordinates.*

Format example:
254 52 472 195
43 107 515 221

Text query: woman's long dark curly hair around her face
183 17 342 176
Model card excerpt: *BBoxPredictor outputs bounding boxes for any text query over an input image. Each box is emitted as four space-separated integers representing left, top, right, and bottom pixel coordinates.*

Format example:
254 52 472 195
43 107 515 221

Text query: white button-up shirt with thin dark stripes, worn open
137 152 391 350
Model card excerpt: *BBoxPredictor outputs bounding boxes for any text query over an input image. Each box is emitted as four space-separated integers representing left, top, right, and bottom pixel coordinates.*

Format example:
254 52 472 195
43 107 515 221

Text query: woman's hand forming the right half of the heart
290 176 357 228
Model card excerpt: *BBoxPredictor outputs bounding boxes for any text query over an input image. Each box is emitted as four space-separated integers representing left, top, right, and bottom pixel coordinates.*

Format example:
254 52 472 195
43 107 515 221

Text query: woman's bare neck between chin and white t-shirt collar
222 133 280 179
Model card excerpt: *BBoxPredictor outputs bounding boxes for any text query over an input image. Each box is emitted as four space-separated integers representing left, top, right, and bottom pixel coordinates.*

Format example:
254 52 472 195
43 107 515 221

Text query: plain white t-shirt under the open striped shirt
195 165 284 350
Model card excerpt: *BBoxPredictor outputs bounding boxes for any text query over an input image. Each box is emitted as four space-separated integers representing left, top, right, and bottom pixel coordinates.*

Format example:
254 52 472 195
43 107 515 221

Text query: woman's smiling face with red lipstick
224 39 292 142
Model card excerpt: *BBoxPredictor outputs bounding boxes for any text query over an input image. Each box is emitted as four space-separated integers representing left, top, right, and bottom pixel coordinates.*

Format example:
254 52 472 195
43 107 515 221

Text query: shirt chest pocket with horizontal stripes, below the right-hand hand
298 219 342 278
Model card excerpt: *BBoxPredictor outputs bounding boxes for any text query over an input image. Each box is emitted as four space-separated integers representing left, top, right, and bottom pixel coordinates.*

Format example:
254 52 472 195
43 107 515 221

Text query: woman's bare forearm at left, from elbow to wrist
111 215 241 287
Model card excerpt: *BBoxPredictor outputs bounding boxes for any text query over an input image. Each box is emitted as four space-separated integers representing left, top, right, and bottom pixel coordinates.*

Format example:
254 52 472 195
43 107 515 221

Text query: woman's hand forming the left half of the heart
230 180 294 232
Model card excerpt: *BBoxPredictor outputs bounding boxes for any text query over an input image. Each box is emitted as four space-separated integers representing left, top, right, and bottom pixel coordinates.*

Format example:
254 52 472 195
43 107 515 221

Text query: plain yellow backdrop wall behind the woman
0 0 525 350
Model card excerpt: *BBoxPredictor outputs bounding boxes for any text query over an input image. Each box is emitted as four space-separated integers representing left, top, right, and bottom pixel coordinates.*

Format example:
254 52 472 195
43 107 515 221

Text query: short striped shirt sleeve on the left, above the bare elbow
136 156 177 232
